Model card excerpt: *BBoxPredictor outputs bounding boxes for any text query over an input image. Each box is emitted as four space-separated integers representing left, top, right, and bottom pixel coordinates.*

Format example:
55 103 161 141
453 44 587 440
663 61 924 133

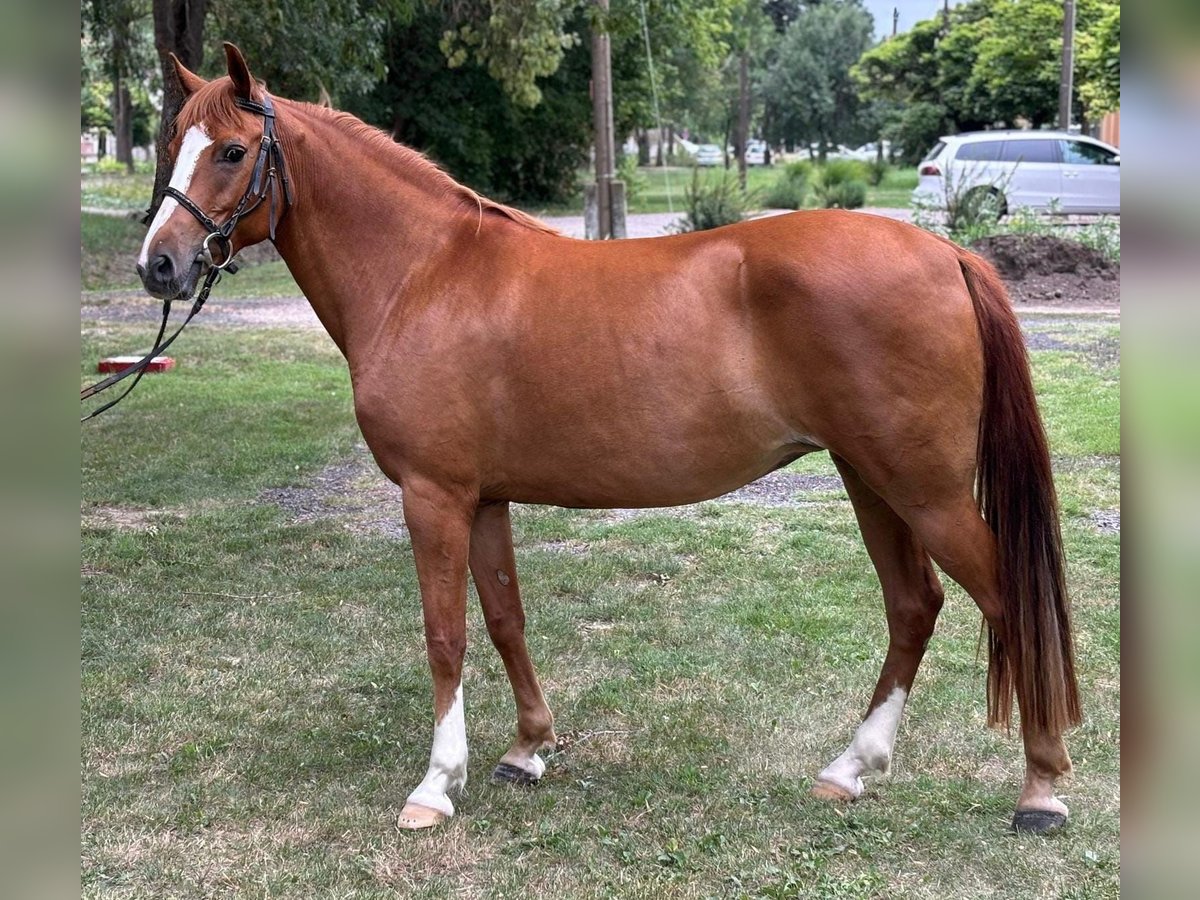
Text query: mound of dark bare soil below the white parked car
971 234 1121 308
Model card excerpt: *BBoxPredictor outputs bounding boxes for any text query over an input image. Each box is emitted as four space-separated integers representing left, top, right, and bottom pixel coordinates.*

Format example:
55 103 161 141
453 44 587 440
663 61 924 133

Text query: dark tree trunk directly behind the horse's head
142 0 209 224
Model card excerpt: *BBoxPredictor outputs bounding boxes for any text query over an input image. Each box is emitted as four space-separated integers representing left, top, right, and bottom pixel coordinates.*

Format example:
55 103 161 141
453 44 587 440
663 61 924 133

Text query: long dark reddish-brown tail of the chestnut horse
958 248 1082 734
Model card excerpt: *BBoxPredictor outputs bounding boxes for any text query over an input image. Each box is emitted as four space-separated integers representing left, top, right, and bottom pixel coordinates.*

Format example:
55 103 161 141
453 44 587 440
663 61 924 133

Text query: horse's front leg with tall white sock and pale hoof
397 481 476 829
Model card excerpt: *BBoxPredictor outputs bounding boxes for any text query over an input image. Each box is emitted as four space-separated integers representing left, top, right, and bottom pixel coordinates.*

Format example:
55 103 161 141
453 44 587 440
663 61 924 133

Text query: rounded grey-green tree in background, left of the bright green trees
764 0 875 158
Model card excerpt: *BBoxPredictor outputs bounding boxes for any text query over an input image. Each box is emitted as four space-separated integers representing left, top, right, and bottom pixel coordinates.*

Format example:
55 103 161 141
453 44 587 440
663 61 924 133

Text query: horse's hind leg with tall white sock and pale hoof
812 456 943 800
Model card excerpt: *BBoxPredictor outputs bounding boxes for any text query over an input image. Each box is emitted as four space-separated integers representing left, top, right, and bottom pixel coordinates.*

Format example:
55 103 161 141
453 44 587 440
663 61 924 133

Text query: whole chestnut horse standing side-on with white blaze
138 44 1080 830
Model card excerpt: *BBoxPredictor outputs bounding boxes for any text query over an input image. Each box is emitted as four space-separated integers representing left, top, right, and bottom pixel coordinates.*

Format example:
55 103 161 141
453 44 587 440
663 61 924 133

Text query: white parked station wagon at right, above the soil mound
913 131 1121 214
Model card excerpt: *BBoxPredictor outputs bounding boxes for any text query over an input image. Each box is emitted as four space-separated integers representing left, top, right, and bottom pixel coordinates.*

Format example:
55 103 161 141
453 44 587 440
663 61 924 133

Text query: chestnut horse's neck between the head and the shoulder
276 104 473 356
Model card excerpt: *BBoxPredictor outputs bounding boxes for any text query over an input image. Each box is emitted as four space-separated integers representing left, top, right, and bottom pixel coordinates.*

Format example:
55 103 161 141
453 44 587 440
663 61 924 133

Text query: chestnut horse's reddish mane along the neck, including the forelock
175 77 560 234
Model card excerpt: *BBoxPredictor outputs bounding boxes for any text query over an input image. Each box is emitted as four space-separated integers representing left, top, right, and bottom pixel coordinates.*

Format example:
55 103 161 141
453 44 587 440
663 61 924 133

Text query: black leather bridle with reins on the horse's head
79 91 293 421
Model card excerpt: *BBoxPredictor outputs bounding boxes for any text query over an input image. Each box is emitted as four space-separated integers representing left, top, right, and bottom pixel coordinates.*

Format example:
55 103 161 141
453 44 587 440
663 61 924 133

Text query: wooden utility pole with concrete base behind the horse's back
583 0 624 240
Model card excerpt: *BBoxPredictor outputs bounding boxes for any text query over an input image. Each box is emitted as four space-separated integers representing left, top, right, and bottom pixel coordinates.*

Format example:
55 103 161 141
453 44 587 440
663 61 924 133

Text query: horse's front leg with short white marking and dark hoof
469 503 554 785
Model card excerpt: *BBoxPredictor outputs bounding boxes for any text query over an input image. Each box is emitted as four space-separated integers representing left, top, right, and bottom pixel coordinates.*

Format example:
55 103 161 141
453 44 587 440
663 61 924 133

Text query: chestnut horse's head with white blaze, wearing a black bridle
137 43 288 298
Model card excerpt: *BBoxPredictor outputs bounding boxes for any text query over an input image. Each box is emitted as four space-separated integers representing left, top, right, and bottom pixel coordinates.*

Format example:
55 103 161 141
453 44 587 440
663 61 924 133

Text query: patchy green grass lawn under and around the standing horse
80 301 1121 899
